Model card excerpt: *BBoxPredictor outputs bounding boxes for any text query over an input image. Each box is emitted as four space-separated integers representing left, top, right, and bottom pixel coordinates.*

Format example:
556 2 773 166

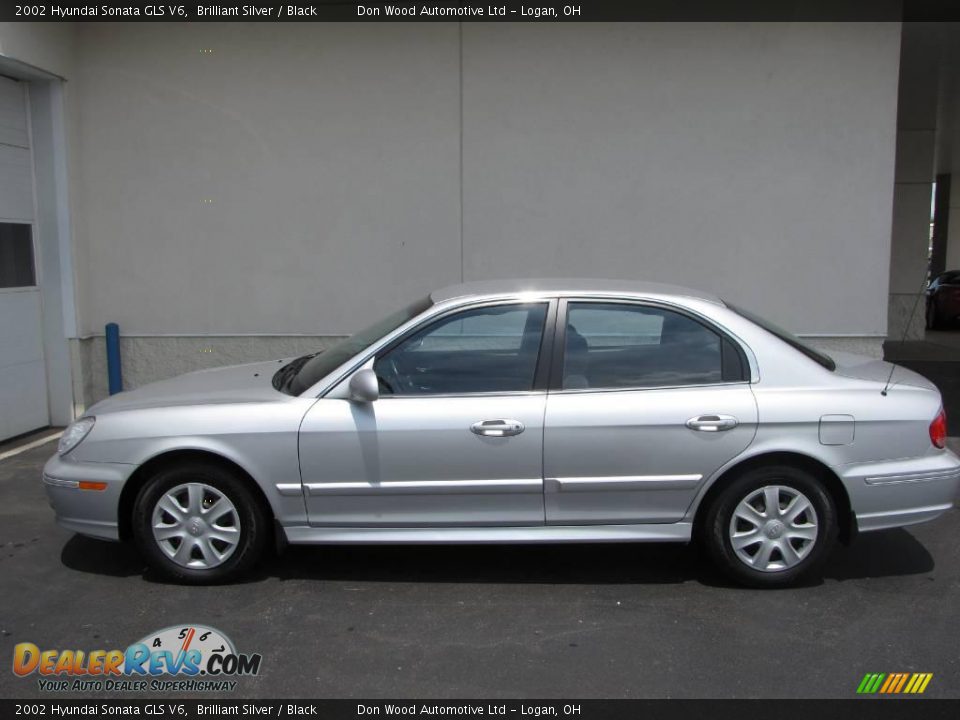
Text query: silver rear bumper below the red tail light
835 450 960 532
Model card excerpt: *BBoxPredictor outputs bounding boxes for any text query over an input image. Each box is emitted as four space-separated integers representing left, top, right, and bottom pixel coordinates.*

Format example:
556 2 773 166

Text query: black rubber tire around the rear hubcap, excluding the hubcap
704 465 837 587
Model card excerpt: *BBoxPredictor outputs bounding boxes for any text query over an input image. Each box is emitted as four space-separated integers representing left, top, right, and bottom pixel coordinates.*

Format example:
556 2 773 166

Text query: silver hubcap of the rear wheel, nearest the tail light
730 485 818 572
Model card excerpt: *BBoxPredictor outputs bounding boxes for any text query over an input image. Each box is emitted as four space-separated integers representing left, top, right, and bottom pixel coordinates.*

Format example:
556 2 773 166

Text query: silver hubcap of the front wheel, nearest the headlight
153 483 240 570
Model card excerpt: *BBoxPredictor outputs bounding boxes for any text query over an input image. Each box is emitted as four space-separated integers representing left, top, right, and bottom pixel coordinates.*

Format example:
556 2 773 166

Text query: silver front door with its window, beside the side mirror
300 301 556 527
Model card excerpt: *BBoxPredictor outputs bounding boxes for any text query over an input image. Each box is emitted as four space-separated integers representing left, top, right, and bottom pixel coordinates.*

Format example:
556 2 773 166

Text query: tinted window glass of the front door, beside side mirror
373 303 547 395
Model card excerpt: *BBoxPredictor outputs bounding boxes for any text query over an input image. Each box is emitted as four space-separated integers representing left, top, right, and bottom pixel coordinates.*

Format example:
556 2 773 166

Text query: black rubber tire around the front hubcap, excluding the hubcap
131 463 268 585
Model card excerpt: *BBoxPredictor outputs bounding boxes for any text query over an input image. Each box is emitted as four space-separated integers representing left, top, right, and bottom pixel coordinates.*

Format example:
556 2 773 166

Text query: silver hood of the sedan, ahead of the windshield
86 358 293 415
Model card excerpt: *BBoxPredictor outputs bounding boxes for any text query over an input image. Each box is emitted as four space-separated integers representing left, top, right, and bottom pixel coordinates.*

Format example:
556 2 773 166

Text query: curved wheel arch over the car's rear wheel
693 451 857 544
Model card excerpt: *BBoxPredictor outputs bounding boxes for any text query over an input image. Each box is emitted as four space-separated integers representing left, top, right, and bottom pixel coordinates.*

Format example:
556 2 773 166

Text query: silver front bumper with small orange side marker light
43 453 136 540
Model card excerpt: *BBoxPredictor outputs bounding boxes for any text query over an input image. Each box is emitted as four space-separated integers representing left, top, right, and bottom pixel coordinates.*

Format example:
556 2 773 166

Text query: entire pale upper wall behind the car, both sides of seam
73 23 899 335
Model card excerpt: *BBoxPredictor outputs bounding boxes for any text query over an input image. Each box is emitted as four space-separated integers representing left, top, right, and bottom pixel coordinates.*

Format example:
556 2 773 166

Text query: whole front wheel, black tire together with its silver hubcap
132 462 270 585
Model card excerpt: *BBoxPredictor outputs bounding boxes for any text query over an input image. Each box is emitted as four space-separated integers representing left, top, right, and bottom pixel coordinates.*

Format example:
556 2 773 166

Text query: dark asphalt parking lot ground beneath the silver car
0 440 960 699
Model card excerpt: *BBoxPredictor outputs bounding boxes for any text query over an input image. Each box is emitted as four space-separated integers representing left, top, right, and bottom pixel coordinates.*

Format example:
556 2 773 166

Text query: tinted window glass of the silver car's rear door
562 302 741 390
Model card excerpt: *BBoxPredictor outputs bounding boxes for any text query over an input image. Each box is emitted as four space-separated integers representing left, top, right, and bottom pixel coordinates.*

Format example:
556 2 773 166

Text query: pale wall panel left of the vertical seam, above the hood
74 23 460 335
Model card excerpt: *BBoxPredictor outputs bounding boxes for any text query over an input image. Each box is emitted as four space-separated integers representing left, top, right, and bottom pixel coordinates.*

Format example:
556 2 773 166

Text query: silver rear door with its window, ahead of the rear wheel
544 299 757 525
